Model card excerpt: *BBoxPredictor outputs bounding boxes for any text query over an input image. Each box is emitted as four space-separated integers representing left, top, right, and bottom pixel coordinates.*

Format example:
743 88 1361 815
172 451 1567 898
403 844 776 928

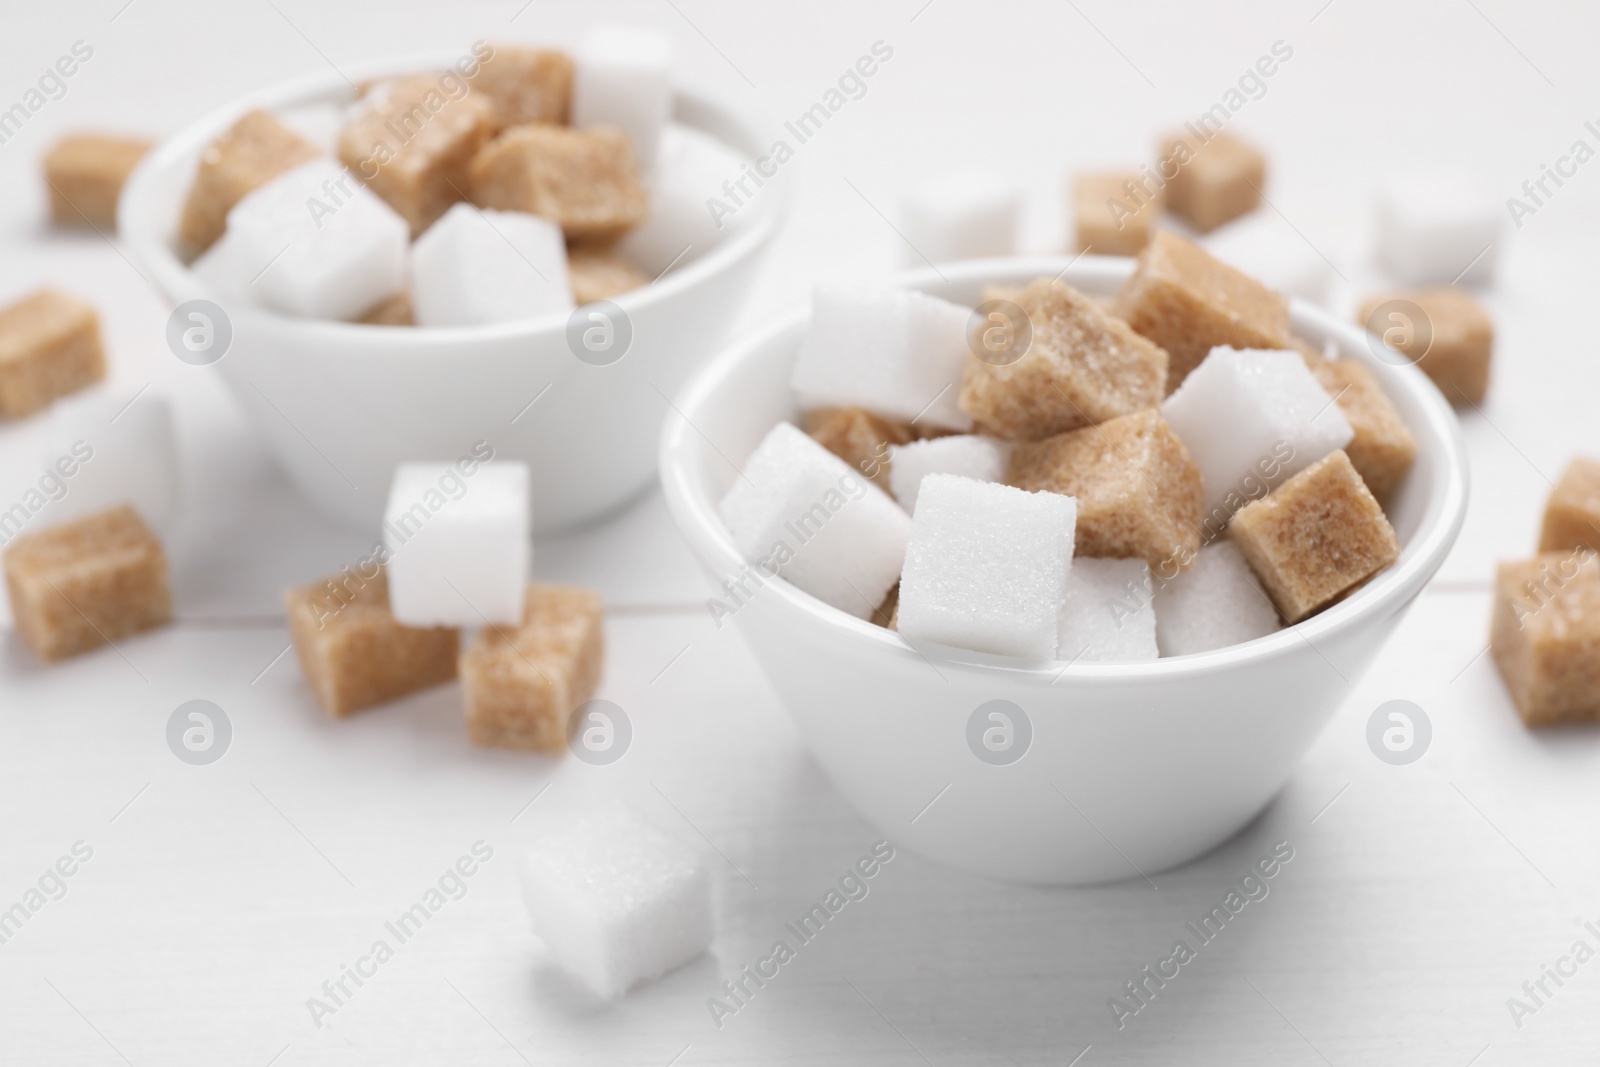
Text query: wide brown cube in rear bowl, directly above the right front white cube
472 126 648 240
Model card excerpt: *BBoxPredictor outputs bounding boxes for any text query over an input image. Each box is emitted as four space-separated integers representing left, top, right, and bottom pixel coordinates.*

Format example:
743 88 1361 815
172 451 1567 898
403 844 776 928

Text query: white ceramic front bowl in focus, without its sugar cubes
661 258 1467 883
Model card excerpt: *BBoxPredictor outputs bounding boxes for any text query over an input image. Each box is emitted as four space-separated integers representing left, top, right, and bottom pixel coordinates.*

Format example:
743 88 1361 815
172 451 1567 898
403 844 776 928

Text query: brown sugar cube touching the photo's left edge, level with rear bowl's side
0 290 106 419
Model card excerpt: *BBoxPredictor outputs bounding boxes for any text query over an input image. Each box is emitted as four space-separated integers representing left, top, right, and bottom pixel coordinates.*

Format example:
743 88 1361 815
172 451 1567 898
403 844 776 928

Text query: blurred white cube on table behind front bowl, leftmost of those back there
901 170 1022 266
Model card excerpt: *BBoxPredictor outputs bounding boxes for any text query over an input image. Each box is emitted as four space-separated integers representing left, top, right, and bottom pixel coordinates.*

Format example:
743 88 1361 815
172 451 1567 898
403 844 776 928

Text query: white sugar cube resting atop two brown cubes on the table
384 459 533 625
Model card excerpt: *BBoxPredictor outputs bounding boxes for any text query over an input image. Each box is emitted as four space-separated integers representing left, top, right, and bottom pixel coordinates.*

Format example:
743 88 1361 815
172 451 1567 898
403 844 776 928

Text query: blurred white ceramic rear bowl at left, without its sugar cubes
118 54 786 530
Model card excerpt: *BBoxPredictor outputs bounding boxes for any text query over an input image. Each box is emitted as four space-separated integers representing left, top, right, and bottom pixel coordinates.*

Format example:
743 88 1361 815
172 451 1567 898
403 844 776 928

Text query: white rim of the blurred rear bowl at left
117 50 792 347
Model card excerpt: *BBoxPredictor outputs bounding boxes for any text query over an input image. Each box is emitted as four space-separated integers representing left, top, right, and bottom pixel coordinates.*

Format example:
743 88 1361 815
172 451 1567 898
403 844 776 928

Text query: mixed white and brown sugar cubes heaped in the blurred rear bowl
175 26 765 326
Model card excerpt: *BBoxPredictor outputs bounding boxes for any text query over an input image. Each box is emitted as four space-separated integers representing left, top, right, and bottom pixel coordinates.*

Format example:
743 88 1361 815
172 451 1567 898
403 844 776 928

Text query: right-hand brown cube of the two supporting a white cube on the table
461 584 605 752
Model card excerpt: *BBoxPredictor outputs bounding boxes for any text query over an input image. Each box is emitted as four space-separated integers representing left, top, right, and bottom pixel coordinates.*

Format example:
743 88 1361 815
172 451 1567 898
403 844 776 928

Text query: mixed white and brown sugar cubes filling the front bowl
720 227 1420 665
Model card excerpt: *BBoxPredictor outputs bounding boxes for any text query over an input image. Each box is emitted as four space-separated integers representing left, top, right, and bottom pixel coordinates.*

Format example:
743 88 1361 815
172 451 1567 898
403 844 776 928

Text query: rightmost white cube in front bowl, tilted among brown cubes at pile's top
1162 346 1355 533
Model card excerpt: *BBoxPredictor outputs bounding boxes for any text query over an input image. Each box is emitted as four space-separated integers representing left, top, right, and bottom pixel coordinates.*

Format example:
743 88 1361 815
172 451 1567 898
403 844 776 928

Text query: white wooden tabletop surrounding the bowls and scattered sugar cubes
0 0 1600 1067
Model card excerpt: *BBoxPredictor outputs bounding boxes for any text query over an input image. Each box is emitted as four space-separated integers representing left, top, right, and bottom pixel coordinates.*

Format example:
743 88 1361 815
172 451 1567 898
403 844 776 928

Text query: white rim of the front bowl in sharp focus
661 256 1467 685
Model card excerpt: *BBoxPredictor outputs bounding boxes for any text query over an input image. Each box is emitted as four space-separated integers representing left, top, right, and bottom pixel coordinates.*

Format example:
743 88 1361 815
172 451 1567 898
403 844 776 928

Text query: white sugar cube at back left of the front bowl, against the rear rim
790 285 973 430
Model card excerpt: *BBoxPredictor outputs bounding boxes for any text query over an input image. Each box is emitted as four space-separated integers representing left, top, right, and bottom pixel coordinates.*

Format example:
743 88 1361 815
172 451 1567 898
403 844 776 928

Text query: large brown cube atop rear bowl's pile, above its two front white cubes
339 74 494 237
